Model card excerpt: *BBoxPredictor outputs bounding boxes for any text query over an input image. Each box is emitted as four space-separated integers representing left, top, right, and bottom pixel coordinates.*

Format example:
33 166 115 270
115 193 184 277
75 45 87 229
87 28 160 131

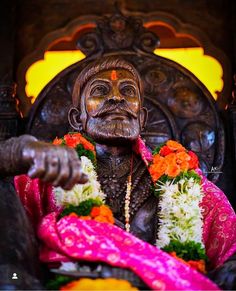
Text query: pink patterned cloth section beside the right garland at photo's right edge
201 176 236 268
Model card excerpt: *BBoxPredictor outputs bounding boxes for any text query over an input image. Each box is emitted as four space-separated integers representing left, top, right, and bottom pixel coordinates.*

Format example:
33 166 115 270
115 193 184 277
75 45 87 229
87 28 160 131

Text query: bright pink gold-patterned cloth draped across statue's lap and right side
15 175 236 290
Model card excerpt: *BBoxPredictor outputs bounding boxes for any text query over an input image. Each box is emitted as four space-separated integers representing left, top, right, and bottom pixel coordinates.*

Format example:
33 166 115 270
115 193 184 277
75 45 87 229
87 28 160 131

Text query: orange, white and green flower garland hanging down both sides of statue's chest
53 133 207 273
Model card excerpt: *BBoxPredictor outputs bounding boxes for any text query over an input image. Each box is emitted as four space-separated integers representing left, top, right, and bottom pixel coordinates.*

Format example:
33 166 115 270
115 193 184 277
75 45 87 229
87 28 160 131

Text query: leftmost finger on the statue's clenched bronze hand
28 153 47 179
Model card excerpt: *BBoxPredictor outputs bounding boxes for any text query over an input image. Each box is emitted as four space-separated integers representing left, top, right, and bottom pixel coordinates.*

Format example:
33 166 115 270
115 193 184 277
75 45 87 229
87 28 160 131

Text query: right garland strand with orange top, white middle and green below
148 140 207 272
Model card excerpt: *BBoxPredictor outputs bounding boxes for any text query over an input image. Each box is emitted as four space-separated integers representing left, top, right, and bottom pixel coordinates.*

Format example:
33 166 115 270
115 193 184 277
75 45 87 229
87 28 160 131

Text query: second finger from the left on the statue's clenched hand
42 154 60 182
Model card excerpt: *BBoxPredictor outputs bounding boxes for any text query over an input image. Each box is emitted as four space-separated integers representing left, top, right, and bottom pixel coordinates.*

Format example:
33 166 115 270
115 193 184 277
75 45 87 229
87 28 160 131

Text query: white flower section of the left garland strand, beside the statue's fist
53 156 105 206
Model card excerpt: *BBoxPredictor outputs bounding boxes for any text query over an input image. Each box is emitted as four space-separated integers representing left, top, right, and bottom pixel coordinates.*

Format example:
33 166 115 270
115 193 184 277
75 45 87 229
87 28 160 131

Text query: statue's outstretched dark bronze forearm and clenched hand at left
0 135 87 189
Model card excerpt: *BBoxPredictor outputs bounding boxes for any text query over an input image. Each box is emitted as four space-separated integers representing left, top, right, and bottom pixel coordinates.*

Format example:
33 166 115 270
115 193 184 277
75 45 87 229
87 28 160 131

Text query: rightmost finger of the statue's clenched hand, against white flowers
64 160 88 190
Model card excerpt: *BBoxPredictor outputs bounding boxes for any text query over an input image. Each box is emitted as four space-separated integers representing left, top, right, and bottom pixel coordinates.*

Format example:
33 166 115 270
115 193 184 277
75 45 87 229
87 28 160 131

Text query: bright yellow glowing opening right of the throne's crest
154 47 224 99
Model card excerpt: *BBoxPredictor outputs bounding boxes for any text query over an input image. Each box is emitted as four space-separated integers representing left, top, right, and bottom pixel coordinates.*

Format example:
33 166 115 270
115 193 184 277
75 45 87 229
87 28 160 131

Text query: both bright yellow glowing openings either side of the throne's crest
25 48 223 103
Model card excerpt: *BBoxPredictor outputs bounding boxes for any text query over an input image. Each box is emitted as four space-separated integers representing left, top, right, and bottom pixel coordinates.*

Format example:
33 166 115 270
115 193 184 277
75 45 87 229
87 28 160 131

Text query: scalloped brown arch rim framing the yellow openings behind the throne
17 7 231 116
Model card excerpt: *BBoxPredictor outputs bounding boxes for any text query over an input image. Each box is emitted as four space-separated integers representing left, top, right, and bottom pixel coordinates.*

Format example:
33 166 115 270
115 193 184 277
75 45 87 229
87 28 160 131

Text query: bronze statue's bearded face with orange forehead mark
80 69 141 144
